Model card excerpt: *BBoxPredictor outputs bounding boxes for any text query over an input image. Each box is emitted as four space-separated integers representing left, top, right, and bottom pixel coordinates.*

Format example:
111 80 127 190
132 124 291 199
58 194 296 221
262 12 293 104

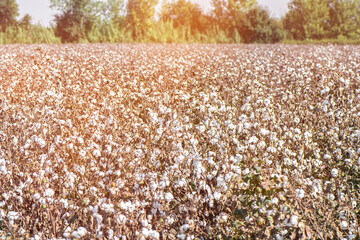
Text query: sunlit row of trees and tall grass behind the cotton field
0 0 360 43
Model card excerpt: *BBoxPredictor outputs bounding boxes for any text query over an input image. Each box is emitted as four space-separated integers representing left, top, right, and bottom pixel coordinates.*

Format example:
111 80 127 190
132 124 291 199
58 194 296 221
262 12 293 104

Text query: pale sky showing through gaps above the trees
16 0 289 26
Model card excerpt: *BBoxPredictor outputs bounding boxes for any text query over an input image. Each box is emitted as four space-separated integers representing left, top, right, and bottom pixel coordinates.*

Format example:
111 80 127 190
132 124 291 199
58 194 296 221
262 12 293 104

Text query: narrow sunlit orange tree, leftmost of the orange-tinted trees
126 0 157 41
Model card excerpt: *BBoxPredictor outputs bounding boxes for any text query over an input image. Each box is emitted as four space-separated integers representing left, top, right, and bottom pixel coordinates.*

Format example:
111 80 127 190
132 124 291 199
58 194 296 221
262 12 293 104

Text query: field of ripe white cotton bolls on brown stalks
0 44 360 240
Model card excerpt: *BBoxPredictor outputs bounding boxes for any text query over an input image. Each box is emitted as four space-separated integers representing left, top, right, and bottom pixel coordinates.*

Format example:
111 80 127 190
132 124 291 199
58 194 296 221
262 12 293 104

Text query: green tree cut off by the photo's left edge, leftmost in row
0 0 19 32
